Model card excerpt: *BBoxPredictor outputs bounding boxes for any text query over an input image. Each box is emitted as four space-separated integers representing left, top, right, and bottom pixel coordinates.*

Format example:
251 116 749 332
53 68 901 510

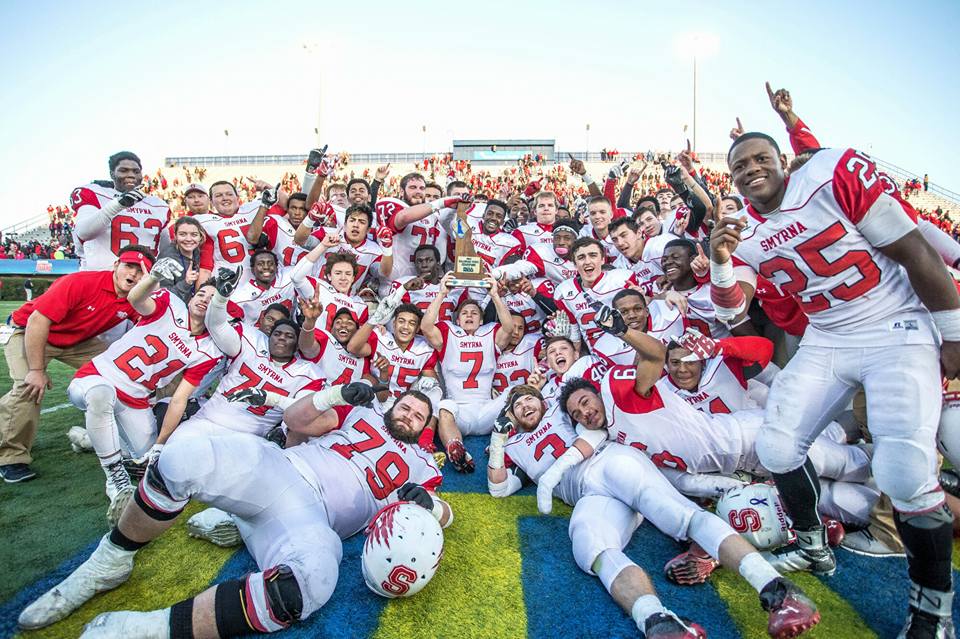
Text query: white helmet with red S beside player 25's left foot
717 484 793 550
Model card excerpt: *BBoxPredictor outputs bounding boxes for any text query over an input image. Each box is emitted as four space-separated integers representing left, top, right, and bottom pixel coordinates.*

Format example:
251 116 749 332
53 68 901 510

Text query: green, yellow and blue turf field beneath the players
0 302 956 639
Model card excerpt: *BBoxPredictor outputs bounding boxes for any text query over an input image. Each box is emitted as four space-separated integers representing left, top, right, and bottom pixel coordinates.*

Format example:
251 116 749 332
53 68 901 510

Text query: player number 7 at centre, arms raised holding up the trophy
420 273 514 472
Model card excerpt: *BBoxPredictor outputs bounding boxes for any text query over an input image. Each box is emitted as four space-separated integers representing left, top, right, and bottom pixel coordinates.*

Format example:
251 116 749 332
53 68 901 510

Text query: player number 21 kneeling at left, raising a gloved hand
67 258 223 523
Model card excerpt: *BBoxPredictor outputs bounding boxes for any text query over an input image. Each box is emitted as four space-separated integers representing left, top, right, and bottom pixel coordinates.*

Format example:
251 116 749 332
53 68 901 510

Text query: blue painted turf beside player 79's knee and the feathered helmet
211 535 387 639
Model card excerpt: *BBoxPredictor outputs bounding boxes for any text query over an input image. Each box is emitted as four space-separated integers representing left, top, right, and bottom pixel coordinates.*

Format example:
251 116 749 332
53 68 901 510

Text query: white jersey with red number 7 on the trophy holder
437 322 500 402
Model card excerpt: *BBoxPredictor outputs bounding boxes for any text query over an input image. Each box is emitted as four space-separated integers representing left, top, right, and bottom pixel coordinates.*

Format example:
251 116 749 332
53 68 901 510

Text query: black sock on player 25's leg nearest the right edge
893 504 953 592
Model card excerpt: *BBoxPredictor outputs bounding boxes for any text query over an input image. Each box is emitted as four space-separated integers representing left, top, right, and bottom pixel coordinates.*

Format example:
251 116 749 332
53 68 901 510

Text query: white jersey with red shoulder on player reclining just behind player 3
600 366 743 474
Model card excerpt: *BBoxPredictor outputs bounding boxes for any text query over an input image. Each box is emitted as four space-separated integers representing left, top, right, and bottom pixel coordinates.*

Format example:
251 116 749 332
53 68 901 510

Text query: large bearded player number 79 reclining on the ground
19 382 453 639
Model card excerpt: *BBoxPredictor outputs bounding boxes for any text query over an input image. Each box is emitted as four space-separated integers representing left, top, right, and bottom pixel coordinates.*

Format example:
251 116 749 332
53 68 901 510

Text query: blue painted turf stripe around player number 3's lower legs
519 517 744 639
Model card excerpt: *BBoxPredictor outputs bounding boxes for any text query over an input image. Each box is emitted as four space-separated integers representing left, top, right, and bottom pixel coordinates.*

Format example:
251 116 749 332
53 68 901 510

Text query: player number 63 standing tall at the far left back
70 151 170 271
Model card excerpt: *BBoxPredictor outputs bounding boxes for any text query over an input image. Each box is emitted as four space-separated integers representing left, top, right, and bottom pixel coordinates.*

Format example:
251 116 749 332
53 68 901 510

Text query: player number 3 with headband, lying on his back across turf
487 385 820 639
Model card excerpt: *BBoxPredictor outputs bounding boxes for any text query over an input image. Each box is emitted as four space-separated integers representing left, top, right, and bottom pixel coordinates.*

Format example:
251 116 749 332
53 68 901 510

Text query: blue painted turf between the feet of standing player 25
821 548 960 637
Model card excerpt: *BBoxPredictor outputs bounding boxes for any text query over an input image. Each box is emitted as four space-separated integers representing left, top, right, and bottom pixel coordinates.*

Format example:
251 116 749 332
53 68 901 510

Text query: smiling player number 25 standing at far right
710 133 960 637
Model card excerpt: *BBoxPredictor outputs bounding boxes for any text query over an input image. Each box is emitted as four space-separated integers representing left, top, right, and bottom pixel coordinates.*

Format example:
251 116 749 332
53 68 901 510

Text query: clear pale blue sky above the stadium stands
0 0 960 227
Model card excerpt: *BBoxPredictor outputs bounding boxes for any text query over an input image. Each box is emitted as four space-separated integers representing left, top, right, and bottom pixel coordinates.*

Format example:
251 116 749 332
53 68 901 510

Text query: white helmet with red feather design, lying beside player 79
361 502 443 599
